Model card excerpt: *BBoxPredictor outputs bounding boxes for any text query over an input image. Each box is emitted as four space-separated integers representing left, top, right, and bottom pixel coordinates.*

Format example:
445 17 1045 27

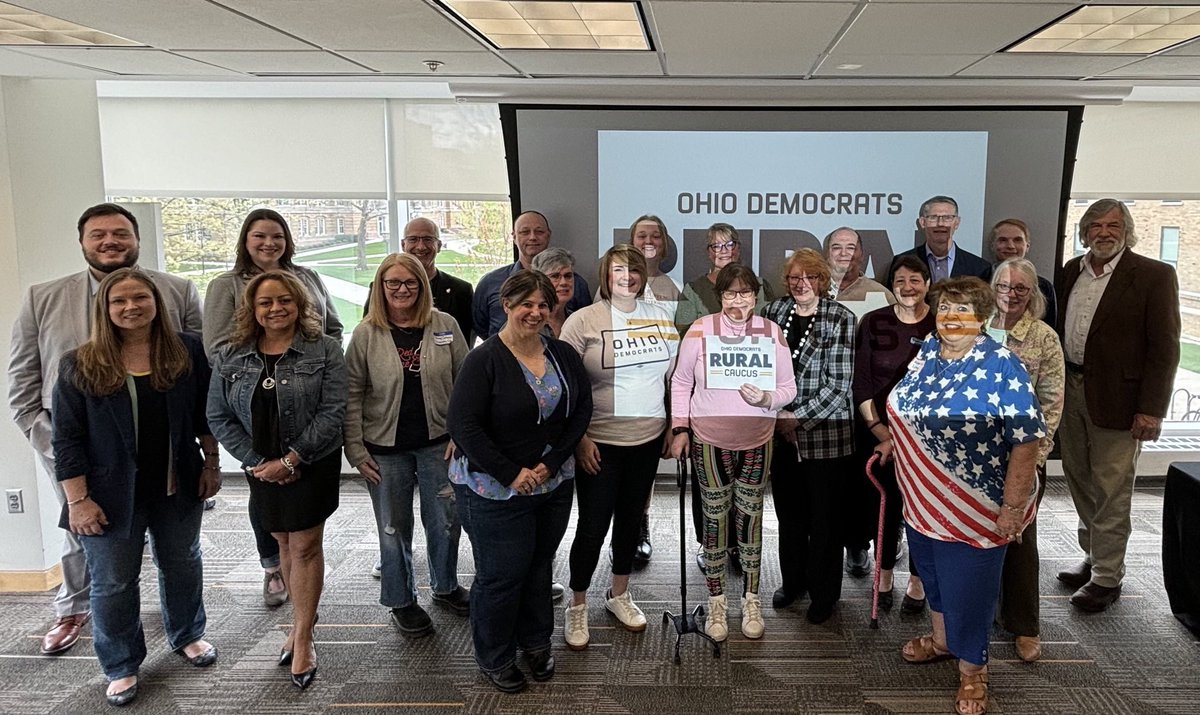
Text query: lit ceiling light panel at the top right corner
1004 5 1200 55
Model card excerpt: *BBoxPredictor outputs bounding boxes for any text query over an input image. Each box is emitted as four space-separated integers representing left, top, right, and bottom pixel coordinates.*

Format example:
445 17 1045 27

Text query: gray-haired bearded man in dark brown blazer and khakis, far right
1057 199 1180 612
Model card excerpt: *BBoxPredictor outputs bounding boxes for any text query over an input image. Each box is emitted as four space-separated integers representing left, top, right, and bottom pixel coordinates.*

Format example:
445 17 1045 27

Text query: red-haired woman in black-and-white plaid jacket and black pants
762 248 854 623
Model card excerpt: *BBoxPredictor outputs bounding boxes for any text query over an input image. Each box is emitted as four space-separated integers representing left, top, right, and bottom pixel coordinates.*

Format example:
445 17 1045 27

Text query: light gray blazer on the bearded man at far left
8 269 203 459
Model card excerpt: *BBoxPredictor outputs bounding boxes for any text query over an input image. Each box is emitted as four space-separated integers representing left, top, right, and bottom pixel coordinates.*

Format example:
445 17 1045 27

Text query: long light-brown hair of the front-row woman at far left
73 268 192 396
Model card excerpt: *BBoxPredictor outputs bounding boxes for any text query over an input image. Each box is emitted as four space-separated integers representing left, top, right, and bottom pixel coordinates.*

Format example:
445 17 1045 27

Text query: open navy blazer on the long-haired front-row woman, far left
50 332 210 539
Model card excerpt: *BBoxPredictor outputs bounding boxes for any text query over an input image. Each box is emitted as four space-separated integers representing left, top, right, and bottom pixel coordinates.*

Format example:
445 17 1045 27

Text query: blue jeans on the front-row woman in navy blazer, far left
79 495 206 680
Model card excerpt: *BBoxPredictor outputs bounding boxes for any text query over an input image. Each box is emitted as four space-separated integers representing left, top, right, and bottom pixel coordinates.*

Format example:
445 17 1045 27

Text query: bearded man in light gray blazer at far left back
8 204 202 654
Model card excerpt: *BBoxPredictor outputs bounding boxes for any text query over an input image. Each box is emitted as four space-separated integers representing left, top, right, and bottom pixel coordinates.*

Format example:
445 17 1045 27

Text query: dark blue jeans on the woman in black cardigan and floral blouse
454 480 575 673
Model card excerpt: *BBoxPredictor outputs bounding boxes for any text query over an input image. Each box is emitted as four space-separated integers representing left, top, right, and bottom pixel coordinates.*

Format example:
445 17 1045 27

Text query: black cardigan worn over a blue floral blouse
446 335 592 485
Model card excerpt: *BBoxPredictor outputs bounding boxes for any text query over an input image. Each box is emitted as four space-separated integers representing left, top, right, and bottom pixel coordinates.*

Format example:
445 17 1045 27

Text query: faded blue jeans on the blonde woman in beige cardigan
367 443 462 608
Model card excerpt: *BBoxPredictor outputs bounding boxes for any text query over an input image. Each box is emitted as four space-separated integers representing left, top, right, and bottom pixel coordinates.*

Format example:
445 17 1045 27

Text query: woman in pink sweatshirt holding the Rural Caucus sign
671 264 796 641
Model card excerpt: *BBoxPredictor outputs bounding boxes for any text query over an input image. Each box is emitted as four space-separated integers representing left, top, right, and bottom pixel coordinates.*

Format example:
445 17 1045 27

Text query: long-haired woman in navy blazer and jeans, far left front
52 269 221 705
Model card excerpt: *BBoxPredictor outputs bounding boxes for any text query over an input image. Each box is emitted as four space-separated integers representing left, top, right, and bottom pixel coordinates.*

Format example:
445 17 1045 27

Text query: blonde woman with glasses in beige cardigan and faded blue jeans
346 253 470 637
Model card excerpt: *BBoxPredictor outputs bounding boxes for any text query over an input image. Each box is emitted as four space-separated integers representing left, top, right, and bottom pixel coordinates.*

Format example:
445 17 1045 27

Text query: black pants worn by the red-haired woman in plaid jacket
770 437 853 606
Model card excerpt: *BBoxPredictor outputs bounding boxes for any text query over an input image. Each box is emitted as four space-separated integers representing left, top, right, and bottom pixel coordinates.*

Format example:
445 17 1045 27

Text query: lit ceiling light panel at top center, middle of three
442 0 650 49
